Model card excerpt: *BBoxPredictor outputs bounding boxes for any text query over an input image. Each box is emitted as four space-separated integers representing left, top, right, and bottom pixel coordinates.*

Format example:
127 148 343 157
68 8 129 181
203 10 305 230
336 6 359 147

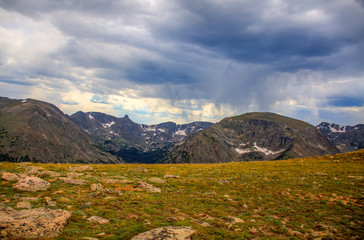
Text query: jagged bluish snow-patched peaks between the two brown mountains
70 112 212 163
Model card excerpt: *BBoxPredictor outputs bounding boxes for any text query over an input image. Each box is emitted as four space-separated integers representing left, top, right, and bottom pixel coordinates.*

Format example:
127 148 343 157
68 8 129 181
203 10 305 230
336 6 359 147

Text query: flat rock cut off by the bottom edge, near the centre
131 227 196 240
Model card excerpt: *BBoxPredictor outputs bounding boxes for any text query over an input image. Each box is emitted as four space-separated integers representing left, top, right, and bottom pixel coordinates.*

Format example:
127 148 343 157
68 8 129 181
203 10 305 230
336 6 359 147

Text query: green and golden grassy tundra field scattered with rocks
0 150 364 240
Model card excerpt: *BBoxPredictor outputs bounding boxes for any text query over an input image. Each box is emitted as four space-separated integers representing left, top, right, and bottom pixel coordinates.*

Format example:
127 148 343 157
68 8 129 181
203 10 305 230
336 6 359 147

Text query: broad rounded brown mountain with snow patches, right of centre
162 113 338 163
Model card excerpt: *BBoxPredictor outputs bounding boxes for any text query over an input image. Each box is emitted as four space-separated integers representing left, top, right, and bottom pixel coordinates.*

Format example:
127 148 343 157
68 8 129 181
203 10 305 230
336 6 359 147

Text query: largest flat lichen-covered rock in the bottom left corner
0 207 71 239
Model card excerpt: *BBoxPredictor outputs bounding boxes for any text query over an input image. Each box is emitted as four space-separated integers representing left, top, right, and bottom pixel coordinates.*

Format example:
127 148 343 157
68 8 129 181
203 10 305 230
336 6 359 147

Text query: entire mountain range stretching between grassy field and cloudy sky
0 97 364 163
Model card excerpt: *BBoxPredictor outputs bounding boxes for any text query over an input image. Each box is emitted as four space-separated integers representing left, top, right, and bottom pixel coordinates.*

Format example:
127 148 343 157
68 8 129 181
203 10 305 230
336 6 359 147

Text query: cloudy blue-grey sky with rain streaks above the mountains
0 0 364 125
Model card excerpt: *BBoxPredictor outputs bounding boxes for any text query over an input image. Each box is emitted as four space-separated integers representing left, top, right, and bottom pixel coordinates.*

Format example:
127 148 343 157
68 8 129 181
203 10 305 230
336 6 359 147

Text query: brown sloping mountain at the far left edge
0 97 122 163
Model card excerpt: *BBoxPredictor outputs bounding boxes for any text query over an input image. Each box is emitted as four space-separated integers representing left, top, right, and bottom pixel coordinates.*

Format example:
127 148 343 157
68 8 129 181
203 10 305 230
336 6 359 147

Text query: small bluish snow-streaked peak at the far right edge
317 122 364 153
